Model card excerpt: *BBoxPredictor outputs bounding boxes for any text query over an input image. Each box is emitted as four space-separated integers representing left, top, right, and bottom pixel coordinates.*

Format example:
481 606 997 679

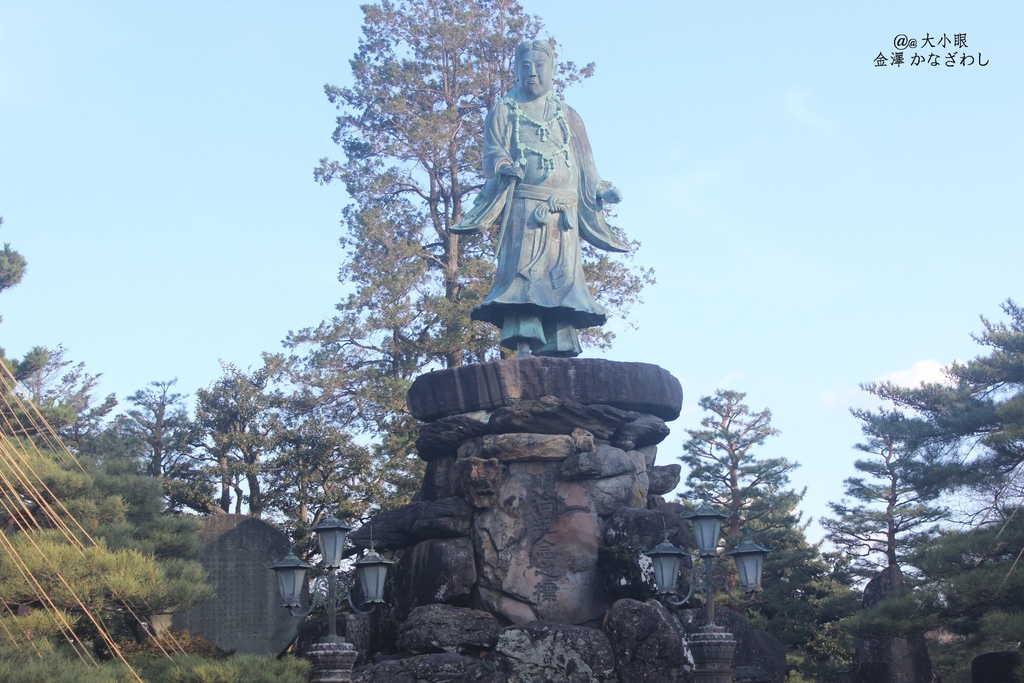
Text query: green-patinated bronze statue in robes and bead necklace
452 40 629 357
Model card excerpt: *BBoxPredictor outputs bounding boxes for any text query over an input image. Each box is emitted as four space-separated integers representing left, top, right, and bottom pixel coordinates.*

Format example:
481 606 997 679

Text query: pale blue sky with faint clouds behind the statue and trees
0 0 1024 540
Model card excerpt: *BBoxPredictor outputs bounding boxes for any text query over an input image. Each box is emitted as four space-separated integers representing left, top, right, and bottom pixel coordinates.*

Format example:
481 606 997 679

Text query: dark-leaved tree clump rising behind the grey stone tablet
186 356 382 528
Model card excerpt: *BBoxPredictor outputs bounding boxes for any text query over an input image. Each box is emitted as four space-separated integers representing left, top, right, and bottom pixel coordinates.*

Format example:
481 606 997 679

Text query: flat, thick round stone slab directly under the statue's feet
407 356 683 422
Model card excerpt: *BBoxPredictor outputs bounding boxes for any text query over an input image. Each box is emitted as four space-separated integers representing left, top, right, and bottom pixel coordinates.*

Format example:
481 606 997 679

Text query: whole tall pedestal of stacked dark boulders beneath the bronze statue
351 357 782 683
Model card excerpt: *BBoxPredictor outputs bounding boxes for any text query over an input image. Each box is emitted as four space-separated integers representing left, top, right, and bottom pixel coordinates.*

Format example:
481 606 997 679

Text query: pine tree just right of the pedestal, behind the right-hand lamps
680 390 859 680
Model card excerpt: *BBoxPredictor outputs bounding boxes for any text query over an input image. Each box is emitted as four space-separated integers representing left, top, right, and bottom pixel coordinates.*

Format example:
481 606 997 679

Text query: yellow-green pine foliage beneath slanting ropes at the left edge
0 438 210 651
